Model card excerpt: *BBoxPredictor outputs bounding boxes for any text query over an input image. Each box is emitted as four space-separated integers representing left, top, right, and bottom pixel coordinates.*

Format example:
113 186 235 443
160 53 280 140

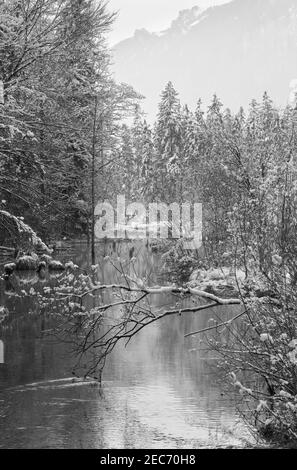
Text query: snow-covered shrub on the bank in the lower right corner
209 270 297 445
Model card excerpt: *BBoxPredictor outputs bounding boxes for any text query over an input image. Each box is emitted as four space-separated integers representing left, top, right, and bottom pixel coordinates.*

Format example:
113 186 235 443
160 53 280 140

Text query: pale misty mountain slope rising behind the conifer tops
110 0 297 115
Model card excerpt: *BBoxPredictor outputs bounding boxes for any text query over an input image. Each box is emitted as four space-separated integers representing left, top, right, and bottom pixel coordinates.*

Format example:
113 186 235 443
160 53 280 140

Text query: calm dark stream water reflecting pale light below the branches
0 243 252 448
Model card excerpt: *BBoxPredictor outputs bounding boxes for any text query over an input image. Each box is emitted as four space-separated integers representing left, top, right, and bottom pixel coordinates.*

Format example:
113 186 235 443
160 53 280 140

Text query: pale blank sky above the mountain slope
109 0 230 45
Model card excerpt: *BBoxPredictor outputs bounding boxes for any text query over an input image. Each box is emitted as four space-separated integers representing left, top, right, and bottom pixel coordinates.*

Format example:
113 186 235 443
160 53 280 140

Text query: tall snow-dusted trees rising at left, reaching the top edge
0 0 139 248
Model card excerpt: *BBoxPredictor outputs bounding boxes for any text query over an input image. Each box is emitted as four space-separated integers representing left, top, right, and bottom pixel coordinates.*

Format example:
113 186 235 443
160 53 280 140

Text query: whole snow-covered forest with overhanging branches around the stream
0 0 297 446
